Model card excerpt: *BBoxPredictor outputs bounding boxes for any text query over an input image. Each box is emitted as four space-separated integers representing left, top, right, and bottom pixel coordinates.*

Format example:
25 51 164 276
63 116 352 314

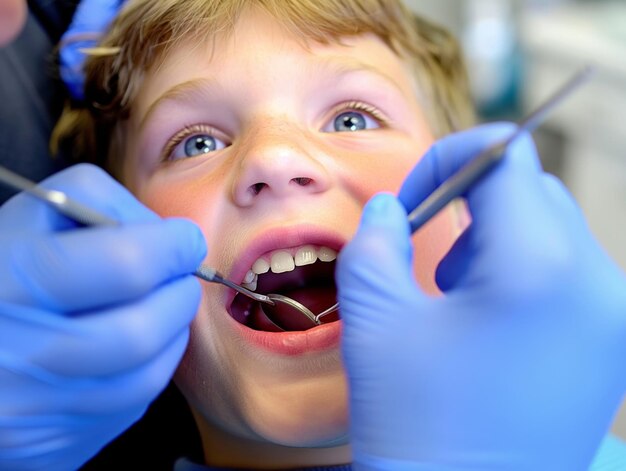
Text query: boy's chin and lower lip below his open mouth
175 293 348 448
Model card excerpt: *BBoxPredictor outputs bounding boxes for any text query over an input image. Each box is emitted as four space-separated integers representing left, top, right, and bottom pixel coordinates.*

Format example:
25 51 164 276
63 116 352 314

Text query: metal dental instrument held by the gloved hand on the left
0 165 276 310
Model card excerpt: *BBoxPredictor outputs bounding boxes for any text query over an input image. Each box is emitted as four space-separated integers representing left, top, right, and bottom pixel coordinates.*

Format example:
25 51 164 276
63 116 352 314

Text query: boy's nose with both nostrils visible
233 121 330 207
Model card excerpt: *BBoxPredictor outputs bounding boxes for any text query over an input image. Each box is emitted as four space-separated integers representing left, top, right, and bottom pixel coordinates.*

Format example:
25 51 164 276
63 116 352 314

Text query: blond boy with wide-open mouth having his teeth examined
51 0 620 469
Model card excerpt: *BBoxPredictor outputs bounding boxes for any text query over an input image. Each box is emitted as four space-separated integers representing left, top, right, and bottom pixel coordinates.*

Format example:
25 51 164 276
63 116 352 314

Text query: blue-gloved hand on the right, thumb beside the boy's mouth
338 125 626 471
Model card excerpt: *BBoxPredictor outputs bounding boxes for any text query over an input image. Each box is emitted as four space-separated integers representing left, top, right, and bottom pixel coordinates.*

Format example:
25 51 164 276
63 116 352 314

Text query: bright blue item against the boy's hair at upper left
59 0 126 100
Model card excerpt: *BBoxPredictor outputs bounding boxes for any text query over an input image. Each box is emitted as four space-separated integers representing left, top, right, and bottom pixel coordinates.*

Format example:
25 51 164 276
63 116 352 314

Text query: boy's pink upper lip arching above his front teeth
226 224 346 306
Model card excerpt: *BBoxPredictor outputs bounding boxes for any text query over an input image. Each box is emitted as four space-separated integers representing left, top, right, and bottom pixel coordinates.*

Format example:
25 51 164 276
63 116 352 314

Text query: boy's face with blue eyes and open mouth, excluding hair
124 5 455 460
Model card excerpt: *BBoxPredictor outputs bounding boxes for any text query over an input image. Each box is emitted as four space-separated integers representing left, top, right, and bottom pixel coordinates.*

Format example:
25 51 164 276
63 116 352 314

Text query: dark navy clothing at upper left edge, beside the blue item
0 0 77 204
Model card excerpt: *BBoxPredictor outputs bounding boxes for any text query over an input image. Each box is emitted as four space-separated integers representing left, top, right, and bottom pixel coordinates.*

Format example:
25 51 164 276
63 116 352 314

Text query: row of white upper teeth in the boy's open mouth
242 245 337 291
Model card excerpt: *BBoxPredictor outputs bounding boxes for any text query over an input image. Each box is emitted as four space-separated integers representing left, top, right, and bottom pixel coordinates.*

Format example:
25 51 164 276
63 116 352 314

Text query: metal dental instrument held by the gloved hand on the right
315 66 594 324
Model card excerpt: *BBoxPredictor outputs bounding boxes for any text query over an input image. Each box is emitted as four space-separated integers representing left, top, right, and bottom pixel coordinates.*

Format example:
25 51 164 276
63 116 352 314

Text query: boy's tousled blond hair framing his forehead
51 0 474 173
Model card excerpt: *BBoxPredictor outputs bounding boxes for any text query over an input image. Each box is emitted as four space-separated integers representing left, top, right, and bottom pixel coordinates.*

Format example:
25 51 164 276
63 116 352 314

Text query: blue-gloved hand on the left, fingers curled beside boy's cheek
0 165 206 470
